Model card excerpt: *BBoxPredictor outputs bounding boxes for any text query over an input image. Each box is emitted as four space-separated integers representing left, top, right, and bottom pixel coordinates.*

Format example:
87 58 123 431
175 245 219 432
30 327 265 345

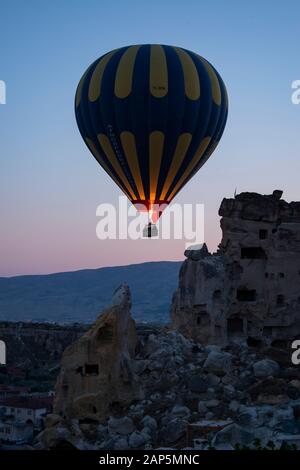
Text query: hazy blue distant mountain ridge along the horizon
0 261 181 323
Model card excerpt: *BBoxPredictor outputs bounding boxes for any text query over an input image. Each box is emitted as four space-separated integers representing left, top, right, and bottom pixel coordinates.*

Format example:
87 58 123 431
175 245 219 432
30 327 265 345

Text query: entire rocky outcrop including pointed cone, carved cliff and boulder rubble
35 191 300 450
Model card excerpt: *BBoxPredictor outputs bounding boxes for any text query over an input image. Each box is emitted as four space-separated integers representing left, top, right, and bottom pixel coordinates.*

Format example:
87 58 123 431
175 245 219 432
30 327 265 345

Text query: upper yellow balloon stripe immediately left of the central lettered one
115 46 141 98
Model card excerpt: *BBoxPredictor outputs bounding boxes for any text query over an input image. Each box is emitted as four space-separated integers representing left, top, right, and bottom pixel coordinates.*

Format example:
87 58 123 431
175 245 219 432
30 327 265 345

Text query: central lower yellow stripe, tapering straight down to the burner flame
149 131 165 202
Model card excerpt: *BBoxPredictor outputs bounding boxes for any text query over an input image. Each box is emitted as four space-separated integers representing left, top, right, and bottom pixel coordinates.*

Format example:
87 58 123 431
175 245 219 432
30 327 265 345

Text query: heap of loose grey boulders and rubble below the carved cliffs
36 306 300 450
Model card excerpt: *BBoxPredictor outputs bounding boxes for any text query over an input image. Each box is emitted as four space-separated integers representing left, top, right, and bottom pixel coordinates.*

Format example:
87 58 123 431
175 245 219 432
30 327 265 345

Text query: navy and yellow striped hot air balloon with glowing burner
75 44 228 236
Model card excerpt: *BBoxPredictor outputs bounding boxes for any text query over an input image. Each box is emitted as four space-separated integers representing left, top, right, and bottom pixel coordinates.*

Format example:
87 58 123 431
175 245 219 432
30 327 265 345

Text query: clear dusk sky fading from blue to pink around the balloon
0 0 300 276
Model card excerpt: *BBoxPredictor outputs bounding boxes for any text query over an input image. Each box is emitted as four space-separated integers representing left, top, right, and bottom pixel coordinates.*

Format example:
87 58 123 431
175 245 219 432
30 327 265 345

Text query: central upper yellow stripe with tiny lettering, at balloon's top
149 45 168 98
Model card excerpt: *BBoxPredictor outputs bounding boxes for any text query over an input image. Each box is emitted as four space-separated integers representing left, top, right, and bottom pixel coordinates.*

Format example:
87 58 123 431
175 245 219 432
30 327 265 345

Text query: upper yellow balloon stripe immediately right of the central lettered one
174 47 200 100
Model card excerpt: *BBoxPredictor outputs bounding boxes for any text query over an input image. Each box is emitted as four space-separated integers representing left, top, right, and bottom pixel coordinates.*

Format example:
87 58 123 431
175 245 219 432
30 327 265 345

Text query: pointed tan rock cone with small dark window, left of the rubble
54 285 141 421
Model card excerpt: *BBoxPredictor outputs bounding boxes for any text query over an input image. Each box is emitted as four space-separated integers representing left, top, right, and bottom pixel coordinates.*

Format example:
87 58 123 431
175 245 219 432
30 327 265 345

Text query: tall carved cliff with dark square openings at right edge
171 190 300 346
